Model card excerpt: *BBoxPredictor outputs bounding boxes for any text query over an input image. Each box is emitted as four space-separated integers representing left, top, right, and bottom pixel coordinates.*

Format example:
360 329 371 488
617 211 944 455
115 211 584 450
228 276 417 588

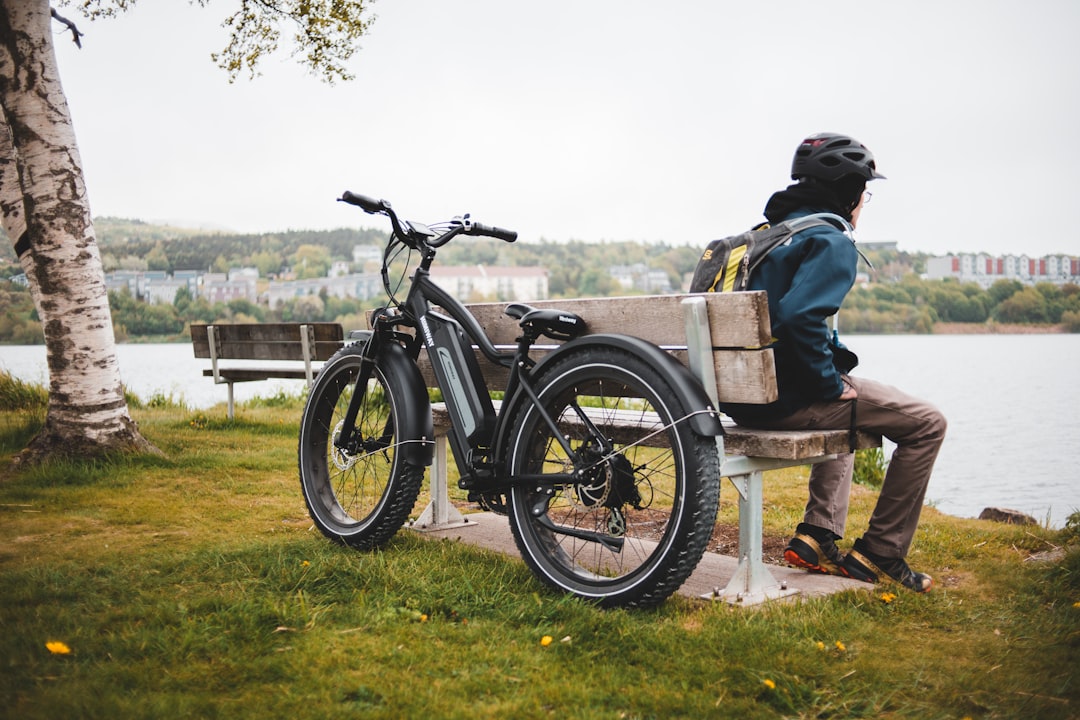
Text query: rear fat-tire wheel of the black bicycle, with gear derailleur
510 347 719 607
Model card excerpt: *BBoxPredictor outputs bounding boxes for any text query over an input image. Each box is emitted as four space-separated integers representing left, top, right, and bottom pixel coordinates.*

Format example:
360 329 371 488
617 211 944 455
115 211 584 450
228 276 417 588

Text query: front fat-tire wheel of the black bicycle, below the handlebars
297 345 424 549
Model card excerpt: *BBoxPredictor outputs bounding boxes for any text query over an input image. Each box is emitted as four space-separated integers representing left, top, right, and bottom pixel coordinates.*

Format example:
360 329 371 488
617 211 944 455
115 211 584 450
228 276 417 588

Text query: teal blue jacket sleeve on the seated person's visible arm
773 228 859 400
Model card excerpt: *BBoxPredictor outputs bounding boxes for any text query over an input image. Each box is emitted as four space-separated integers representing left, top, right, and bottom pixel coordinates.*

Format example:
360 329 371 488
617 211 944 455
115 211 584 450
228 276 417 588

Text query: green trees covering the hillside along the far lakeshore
0 218 1080 344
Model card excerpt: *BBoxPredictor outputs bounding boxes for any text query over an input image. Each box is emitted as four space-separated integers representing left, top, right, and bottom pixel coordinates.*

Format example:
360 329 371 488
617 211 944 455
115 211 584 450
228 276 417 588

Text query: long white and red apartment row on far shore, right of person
927 253 1080 288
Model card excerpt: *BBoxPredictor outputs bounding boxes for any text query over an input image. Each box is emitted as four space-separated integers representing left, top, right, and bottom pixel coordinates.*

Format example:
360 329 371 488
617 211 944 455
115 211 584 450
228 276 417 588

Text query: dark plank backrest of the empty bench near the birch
191 323 345 361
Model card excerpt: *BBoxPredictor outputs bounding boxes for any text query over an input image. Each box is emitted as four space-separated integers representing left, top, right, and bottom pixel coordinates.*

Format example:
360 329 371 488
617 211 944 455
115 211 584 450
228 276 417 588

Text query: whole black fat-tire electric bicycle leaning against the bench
298 192 723 607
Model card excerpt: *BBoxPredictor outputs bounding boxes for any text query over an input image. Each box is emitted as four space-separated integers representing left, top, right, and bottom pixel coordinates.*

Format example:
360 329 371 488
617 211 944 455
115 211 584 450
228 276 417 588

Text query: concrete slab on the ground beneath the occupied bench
413 513 874 599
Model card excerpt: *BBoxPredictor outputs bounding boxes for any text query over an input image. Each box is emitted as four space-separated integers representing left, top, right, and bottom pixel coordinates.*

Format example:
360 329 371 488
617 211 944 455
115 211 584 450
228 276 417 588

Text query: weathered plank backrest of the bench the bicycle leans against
410 293 777 404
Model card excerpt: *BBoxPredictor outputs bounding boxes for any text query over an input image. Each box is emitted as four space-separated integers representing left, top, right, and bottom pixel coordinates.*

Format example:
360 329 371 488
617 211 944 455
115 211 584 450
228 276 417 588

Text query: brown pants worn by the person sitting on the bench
754 376 946 557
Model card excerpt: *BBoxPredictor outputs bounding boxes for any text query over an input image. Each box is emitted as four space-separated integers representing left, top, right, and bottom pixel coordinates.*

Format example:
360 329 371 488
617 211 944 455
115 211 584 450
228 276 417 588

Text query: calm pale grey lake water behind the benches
0 335 1080 527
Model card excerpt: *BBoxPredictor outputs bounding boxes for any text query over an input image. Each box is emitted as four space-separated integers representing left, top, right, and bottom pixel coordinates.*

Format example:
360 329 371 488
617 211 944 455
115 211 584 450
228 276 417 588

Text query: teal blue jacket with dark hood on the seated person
720 207 859 424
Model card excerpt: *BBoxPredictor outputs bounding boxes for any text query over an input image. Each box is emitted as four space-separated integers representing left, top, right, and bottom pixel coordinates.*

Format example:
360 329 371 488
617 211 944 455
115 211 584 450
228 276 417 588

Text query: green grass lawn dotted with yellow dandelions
0 388 1080 720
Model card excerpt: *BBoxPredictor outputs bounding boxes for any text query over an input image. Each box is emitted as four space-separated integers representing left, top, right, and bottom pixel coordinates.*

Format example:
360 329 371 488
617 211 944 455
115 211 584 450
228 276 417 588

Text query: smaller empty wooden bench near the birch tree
191 323 345 420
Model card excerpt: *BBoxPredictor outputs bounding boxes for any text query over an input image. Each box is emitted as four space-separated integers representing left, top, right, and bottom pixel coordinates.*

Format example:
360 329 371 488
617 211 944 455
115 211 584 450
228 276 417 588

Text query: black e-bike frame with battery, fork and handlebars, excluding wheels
336 193 723 493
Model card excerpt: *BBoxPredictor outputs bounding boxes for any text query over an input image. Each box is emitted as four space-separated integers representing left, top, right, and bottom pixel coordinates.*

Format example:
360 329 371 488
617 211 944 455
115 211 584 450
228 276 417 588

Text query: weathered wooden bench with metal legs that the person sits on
414 293 881 603
